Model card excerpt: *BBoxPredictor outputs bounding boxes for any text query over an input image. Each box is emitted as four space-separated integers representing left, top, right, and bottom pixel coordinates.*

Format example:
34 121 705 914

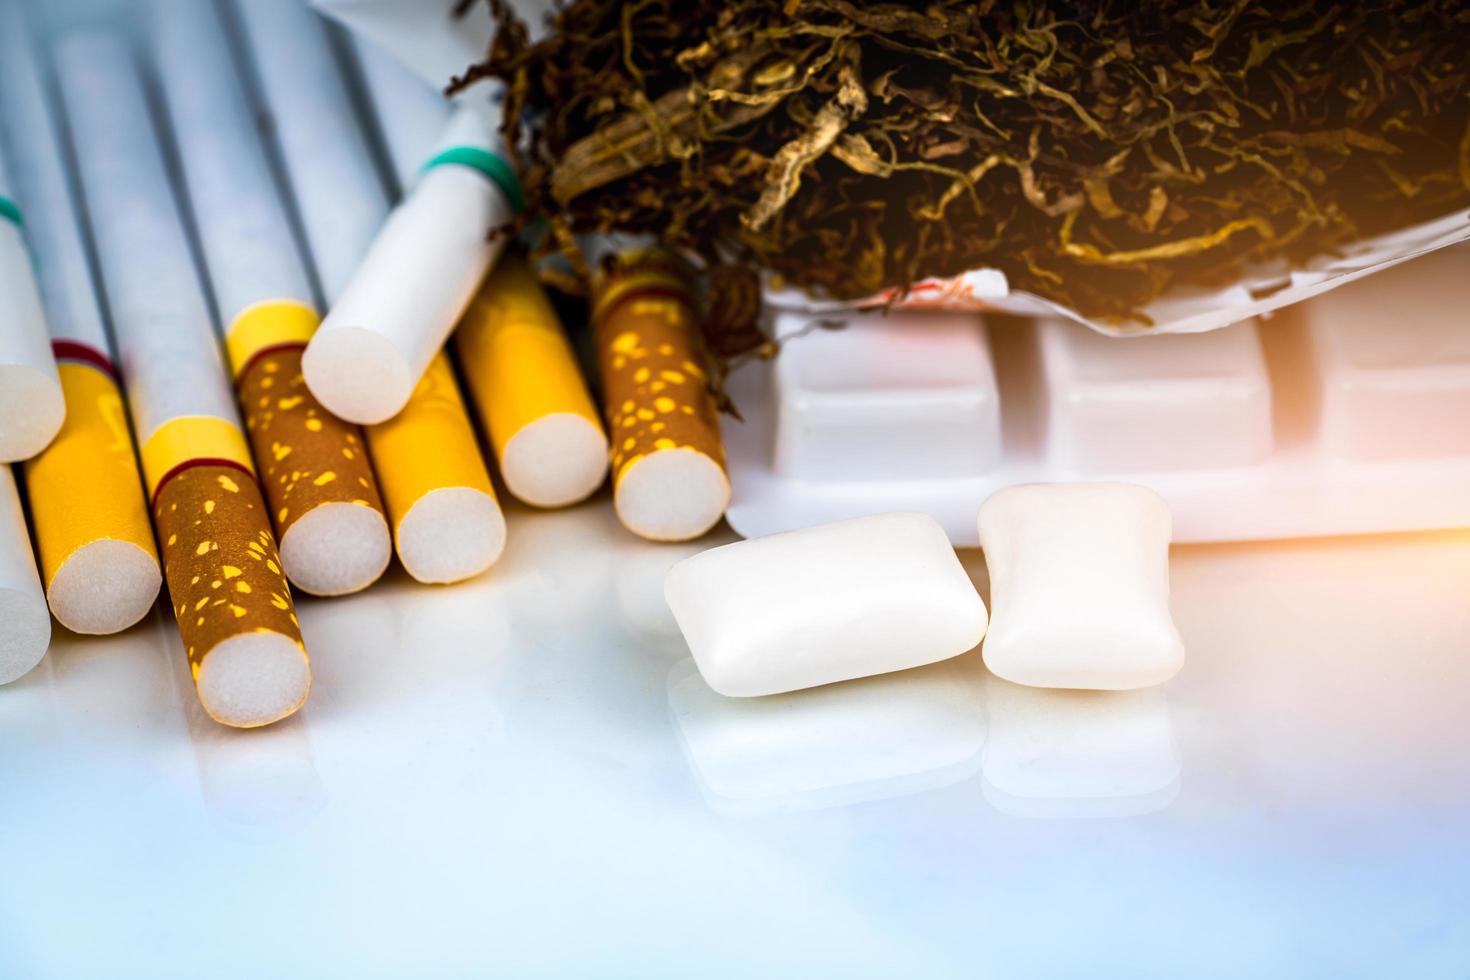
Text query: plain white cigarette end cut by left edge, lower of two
0 464 51 685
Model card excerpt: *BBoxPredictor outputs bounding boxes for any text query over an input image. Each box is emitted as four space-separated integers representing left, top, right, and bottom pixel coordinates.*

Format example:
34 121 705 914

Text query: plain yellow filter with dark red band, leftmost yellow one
25 341 163 633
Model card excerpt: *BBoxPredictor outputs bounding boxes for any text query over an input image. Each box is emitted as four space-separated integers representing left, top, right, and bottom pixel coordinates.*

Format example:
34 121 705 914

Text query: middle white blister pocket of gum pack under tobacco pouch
1036 320 1272 473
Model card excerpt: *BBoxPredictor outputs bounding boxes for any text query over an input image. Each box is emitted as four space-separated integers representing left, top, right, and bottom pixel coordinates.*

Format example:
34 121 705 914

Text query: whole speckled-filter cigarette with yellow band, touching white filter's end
151 0 392 595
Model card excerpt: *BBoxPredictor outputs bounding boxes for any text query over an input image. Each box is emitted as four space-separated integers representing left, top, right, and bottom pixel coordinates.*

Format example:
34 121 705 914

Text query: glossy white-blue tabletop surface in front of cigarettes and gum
0 494 1470 980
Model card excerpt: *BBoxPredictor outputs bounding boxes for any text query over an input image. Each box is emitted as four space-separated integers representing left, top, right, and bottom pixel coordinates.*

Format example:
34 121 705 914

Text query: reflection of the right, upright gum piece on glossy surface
982 676 1180 817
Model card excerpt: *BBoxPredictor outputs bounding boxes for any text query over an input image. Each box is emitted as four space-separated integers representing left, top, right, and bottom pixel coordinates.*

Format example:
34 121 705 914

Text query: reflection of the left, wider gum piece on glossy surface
669 660 985 815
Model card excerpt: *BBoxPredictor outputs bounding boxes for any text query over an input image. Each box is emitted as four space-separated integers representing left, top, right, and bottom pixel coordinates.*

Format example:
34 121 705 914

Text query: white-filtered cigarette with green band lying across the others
303 48 522 423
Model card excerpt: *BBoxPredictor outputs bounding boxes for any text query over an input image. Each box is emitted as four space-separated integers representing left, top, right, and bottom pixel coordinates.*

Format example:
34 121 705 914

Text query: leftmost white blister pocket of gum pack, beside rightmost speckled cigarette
776 313 1001 480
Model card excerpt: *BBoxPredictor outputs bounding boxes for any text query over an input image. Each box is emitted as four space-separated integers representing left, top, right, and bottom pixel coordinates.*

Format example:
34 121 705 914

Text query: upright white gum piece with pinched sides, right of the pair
979 483 1185 691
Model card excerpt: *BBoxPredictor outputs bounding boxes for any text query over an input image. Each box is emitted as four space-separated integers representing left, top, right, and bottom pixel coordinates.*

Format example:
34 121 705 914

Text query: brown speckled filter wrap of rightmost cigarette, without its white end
592 250 725 489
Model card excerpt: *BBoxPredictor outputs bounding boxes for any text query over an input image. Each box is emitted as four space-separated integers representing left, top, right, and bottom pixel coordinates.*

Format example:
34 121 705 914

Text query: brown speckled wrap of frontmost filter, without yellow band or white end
153 464 304 679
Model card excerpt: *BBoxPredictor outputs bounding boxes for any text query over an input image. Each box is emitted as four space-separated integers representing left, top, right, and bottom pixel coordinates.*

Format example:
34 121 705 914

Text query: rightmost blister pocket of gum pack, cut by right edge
1279 245 1470 461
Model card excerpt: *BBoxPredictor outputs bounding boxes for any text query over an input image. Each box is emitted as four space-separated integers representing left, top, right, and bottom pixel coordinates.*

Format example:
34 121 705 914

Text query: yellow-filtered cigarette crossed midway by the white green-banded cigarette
237 7 506 582
